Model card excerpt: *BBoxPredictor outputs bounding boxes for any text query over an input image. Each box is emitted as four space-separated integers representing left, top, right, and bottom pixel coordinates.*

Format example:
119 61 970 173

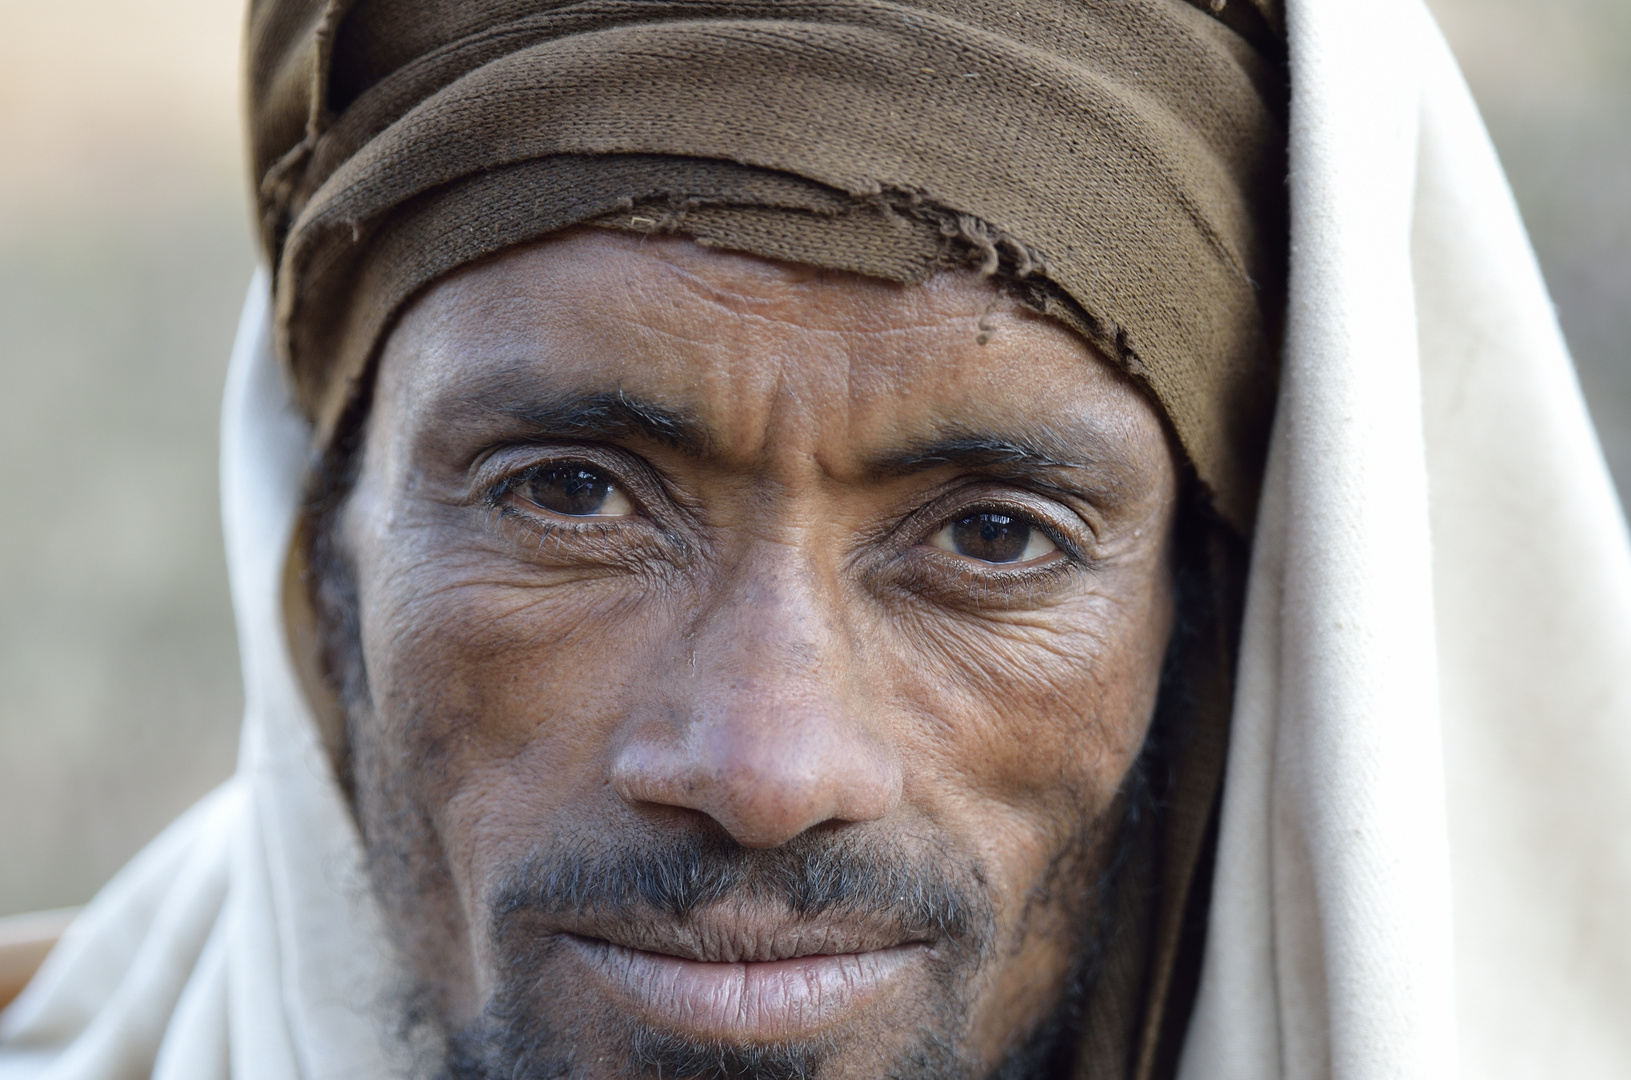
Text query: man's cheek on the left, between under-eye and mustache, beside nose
362 544 670 899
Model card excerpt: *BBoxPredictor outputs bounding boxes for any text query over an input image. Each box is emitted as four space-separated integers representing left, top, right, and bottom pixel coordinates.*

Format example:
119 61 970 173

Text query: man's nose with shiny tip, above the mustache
612 545 902 847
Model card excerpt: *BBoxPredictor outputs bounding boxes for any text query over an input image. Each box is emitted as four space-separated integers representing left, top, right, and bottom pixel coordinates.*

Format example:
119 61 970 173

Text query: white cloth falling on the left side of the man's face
0 272 411 1080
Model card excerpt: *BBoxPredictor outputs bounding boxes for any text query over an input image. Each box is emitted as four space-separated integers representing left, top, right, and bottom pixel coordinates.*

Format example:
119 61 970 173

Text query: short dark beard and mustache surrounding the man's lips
427 830 1119 1080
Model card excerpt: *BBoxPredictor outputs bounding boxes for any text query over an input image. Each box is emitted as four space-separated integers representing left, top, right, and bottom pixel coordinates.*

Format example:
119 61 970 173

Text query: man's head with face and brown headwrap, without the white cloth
270 3 1282 1077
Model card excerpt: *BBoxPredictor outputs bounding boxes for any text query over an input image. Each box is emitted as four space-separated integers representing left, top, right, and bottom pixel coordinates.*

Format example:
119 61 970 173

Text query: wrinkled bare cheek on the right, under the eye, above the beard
895 574 1171 935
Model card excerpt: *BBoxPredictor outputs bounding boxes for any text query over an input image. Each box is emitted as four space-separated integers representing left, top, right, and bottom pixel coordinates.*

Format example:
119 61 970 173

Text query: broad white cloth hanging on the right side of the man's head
1181 0 1631 1080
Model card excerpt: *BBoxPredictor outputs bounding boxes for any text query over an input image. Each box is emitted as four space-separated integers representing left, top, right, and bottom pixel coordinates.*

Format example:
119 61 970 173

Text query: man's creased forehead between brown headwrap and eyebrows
380 230 1165 470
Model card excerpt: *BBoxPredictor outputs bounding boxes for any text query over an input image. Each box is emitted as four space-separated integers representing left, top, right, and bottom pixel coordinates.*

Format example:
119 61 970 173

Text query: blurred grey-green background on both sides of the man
0 0 1631 915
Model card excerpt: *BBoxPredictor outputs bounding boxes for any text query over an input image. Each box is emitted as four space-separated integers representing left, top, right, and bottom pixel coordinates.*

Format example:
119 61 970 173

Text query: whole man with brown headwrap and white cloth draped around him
0 0 1631 1078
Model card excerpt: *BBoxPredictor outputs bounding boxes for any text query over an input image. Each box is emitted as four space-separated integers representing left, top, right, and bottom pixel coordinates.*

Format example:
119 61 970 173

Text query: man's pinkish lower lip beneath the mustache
564 935 928 1041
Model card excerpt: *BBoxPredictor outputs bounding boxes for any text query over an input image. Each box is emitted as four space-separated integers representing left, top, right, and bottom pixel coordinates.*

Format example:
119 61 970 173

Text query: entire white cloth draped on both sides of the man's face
0 0 1631 1080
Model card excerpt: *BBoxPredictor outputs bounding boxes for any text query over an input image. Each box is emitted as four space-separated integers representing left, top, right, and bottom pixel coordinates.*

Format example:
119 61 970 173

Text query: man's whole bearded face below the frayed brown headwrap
338 232 1176 1078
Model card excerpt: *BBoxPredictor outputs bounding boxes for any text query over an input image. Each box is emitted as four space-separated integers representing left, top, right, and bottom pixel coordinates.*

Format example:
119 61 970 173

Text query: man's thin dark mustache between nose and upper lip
488 832 993 943
